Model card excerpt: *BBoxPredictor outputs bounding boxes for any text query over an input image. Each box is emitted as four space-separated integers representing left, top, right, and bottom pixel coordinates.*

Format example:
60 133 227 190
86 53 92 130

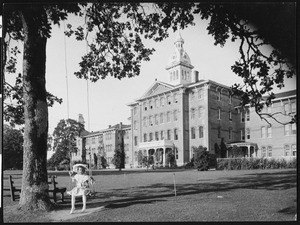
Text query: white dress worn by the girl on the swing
67 174 92 196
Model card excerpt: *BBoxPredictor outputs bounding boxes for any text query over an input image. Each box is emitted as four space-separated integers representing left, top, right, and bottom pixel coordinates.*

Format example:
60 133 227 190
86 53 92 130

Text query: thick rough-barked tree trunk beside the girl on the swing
19 5 52 211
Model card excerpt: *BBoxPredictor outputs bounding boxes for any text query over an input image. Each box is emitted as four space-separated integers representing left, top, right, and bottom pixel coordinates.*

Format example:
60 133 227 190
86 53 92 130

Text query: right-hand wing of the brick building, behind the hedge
245 90 297 157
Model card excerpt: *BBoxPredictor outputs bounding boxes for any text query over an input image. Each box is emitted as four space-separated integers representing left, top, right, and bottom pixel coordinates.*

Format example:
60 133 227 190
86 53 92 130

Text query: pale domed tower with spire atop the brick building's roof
166 31 194 86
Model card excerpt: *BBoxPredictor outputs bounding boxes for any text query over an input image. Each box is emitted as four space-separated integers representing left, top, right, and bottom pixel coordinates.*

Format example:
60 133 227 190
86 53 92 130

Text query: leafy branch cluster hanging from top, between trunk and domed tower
65 2 193 82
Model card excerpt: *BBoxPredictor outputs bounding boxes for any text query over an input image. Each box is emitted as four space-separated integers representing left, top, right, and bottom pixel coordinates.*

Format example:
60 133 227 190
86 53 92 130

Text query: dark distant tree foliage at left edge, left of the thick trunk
3 125 23 170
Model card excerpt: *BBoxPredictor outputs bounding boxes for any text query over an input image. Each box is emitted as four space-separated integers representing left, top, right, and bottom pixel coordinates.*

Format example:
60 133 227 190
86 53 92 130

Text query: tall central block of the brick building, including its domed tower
128 33 245 165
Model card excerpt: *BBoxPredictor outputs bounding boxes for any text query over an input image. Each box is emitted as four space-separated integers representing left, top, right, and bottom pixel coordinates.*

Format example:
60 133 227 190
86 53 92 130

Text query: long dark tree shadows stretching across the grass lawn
52 171 297 214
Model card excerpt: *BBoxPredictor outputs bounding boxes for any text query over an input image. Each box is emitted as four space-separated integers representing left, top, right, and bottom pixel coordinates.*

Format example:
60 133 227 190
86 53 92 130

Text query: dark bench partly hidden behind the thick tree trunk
3 175 67 203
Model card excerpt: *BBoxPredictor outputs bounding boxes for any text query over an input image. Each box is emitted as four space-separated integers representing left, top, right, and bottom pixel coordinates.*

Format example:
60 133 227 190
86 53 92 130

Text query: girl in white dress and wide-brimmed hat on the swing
67 164 95 214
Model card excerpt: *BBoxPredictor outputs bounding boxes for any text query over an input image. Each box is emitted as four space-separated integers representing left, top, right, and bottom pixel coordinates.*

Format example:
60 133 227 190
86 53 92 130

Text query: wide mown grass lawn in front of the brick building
3 169 297 223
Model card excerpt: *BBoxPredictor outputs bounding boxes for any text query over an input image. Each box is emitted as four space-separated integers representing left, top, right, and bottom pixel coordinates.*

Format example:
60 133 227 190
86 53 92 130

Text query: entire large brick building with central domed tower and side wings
73 33 297 167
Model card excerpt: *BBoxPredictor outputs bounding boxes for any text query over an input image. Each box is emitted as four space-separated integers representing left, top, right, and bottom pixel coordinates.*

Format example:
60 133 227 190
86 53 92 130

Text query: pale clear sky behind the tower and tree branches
3 5 296 135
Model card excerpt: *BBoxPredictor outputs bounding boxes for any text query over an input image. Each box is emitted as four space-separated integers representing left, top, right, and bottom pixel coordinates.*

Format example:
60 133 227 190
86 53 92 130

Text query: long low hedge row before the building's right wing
216 157 297 170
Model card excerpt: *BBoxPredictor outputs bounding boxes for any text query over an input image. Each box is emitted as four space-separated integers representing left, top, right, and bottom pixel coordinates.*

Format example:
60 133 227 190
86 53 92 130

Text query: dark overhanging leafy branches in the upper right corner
194 3 296 124
